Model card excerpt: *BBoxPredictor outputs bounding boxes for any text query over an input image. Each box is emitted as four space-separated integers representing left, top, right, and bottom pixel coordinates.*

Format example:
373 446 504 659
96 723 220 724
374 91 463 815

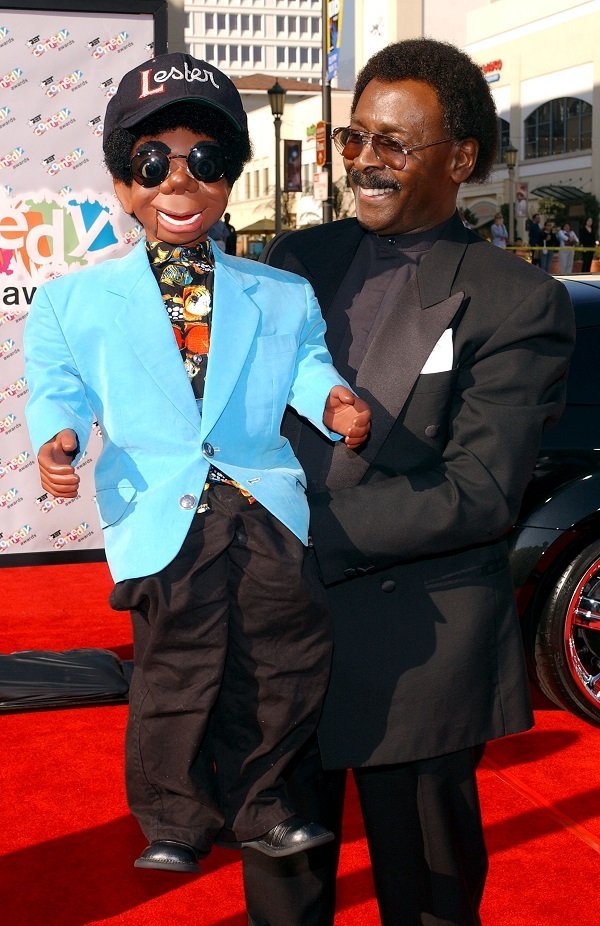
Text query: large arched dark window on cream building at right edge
525 96 592 158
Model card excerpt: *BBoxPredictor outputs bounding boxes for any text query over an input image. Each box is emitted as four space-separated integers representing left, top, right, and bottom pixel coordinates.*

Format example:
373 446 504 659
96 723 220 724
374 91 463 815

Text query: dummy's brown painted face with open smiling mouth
114 128 231 246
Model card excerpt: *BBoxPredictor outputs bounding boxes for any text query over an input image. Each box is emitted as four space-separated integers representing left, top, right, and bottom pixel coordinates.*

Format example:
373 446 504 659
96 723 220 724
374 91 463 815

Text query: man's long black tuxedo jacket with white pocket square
263 217 574 767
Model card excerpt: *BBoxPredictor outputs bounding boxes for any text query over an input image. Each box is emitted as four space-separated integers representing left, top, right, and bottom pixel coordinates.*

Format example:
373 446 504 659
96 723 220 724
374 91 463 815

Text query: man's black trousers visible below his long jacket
243 748 487 926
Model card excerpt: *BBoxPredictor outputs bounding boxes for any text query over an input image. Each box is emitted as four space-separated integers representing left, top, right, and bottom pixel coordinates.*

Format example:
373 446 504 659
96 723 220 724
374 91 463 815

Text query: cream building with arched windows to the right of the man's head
461 0 600 238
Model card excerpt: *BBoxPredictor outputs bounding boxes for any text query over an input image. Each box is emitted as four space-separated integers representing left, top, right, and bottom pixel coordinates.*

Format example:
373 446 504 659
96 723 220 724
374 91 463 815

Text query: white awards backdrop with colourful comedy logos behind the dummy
0 0 166 566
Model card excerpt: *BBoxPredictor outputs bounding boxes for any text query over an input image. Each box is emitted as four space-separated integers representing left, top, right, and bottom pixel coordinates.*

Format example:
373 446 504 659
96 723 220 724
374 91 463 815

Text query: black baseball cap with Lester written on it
104 52 248 141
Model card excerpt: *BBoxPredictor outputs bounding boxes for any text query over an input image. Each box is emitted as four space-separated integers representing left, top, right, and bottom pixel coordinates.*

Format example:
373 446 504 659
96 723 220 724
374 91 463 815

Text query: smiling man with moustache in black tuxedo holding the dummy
245 39 574 926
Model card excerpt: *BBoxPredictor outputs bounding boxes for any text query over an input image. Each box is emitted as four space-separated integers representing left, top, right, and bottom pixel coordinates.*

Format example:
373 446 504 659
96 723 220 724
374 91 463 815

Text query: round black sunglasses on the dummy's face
129 141 225 187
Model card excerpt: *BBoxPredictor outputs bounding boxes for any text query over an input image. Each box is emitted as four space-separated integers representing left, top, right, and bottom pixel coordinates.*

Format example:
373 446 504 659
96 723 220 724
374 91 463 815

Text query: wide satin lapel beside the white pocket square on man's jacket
327 224 466 489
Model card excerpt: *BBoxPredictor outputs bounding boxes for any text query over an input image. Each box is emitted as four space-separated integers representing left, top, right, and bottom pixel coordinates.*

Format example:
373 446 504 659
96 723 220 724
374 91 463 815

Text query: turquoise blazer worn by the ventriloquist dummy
24 241 347 582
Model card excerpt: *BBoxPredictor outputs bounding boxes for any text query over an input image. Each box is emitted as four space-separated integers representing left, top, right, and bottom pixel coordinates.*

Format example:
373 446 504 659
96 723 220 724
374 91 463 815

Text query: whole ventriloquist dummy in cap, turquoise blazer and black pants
25 53 369 872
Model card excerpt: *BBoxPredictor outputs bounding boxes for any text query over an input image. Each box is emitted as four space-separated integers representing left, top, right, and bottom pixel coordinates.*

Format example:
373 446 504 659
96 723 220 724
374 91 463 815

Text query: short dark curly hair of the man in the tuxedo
351 39 498 183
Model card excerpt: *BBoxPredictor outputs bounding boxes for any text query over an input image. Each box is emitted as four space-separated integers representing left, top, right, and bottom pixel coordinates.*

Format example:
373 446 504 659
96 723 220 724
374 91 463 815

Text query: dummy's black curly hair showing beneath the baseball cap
104 101 252 186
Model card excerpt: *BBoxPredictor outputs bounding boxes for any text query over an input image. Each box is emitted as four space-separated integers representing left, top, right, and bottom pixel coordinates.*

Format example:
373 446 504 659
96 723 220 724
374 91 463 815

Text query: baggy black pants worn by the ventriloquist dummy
111 485 331 852
